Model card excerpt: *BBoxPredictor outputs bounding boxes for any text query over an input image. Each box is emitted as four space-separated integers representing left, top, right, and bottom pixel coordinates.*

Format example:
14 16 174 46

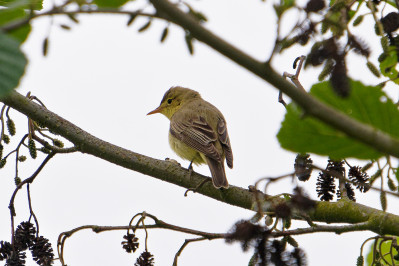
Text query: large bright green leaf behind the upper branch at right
277 81 399 159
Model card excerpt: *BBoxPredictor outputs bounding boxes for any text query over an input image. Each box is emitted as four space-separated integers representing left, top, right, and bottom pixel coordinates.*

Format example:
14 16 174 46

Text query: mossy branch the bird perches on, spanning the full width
0 91 399 235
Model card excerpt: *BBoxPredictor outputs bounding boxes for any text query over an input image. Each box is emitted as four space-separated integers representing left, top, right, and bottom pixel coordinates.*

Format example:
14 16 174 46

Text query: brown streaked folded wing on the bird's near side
170 117 222 162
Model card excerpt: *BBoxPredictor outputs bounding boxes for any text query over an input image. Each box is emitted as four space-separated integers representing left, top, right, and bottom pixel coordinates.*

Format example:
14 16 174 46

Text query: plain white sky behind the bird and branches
0 0 397 266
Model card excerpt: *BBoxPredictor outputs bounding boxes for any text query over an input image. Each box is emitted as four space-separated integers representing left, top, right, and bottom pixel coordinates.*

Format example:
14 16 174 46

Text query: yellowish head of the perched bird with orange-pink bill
147 87 201 119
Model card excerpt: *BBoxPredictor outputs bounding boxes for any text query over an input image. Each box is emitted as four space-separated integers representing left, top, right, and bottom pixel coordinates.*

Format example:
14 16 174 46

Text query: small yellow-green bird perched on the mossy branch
147 87 233 188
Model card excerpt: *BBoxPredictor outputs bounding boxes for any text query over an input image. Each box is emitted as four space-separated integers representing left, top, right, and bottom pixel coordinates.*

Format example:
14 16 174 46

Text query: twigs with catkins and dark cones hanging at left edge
0 93 76 265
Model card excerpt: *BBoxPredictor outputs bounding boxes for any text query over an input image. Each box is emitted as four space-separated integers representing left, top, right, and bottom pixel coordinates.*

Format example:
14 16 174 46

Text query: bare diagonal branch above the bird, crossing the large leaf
150 0 399 158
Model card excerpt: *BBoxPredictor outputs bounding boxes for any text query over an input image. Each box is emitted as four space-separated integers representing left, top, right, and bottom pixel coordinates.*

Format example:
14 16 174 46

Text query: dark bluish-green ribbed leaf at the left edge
0 32 27 96
